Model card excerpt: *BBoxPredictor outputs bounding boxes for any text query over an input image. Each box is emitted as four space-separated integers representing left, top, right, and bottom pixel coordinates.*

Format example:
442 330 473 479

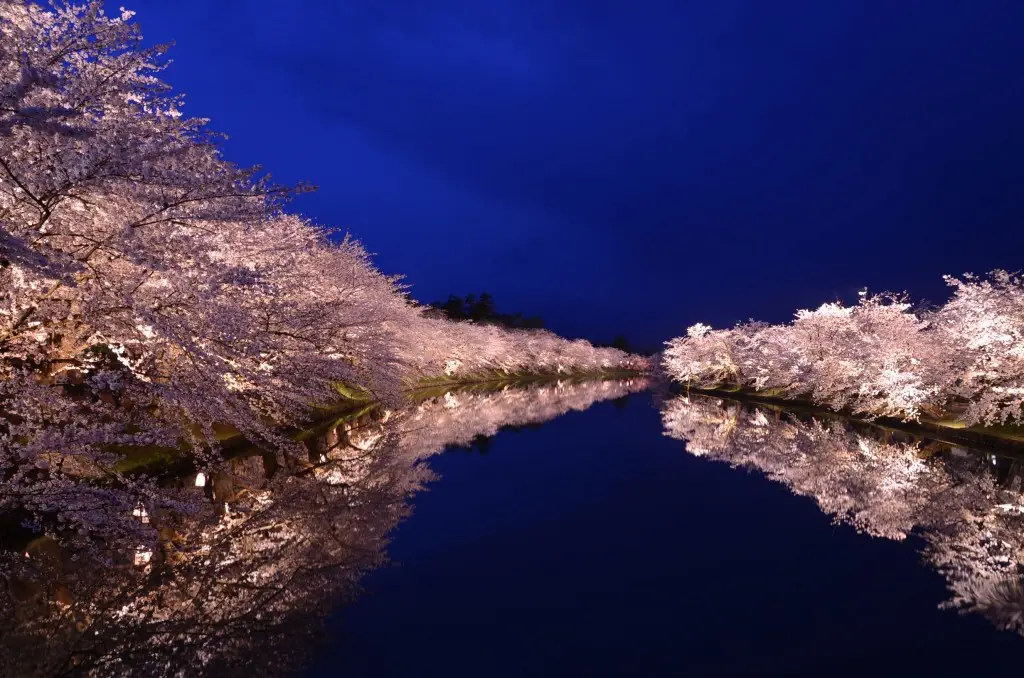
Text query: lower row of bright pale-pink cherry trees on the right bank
663 271 1024 424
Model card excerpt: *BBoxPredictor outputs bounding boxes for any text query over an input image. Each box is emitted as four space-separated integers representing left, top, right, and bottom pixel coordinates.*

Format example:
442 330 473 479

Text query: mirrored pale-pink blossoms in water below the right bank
662 396 1024 634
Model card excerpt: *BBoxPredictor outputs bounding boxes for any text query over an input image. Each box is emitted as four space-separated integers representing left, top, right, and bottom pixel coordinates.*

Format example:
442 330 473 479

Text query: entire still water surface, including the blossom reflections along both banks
12 380 1024 678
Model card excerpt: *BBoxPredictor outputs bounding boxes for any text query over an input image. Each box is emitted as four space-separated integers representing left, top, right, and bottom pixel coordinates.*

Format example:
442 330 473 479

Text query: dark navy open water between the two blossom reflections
305 394 1024 676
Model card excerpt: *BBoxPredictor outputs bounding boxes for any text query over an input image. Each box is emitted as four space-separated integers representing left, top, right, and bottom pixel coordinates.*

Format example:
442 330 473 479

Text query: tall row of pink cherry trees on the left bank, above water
0 0 642 520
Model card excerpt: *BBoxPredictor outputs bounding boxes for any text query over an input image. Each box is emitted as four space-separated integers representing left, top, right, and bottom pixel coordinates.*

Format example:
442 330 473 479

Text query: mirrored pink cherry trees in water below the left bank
0 380 646 676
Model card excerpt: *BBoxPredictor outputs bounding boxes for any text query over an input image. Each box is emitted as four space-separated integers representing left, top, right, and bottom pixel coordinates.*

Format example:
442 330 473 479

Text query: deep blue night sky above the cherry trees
112 0 1024 343
